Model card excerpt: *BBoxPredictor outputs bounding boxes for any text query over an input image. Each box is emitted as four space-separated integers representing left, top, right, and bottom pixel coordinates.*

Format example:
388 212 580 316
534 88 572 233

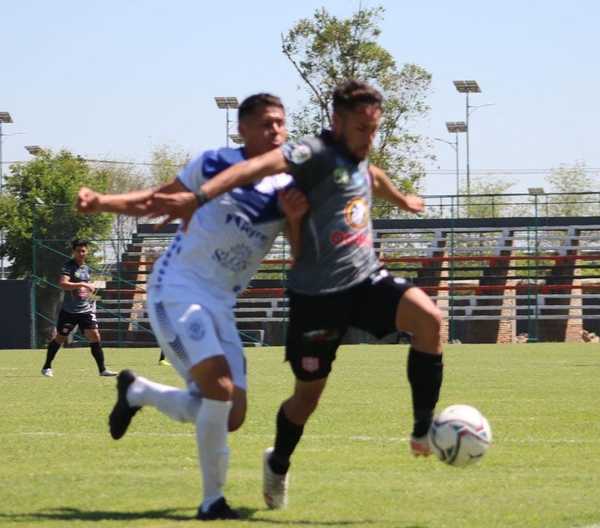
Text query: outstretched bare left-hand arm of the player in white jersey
77 179 187 216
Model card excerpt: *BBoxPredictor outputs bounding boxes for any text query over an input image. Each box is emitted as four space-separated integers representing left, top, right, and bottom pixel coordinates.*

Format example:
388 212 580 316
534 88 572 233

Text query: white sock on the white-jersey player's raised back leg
127 376 202 422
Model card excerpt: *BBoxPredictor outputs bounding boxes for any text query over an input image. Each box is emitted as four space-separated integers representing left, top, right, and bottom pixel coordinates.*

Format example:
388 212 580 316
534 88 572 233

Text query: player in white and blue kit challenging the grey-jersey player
78 94 308 520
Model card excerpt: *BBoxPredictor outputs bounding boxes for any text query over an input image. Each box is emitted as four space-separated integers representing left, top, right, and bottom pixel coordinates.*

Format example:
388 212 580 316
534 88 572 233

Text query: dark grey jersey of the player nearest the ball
282 131 380 295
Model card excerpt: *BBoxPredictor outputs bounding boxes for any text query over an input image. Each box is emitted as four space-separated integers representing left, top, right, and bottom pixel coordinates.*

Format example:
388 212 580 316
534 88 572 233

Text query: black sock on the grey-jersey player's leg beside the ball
406 347 444 437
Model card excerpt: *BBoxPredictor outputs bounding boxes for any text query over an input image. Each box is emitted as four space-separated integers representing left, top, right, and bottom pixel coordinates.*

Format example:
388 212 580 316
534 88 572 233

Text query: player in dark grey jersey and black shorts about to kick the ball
139 81 443 508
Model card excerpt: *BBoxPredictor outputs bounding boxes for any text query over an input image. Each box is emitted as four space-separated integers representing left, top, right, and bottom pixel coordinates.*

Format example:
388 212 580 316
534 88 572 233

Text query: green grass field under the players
0 344 600 528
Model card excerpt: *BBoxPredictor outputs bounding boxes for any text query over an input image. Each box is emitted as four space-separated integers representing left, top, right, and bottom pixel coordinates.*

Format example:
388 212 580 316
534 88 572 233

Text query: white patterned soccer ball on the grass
429 405 492 467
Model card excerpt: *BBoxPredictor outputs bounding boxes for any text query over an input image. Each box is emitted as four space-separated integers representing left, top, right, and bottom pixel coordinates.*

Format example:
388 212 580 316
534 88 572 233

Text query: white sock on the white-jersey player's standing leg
196 398 231 511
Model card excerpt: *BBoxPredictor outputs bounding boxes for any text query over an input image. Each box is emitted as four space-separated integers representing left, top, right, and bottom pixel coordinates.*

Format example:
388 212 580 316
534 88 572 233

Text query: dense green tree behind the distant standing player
0 151 111 342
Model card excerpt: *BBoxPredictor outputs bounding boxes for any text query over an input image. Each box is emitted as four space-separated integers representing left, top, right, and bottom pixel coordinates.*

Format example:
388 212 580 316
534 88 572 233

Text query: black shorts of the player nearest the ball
285 269 413 381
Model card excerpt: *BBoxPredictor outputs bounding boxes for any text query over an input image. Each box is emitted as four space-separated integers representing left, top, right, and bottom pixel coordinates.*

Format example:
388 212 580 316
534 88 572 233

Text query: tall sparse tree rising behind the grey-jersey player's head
282 7 431 199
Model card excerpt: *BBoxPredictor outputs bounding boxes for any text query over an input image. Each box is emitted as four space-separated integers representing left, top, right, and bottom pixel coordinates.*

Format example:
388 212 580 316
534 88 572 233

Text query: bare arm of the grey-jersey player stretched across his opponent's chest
148 148 288 227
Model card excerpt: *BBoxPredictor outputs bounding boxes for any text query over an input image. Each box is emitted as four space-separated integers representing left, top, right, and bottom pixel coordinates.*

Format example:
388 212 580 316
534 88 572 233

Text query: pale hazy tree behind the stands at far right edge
544 163 600 216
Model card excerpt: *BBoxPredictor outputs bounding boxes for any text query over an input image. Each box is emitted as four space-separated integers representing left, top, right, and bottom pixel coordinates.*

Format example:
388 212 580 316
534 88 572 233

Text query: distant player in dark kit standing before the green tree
42 239 117 378
